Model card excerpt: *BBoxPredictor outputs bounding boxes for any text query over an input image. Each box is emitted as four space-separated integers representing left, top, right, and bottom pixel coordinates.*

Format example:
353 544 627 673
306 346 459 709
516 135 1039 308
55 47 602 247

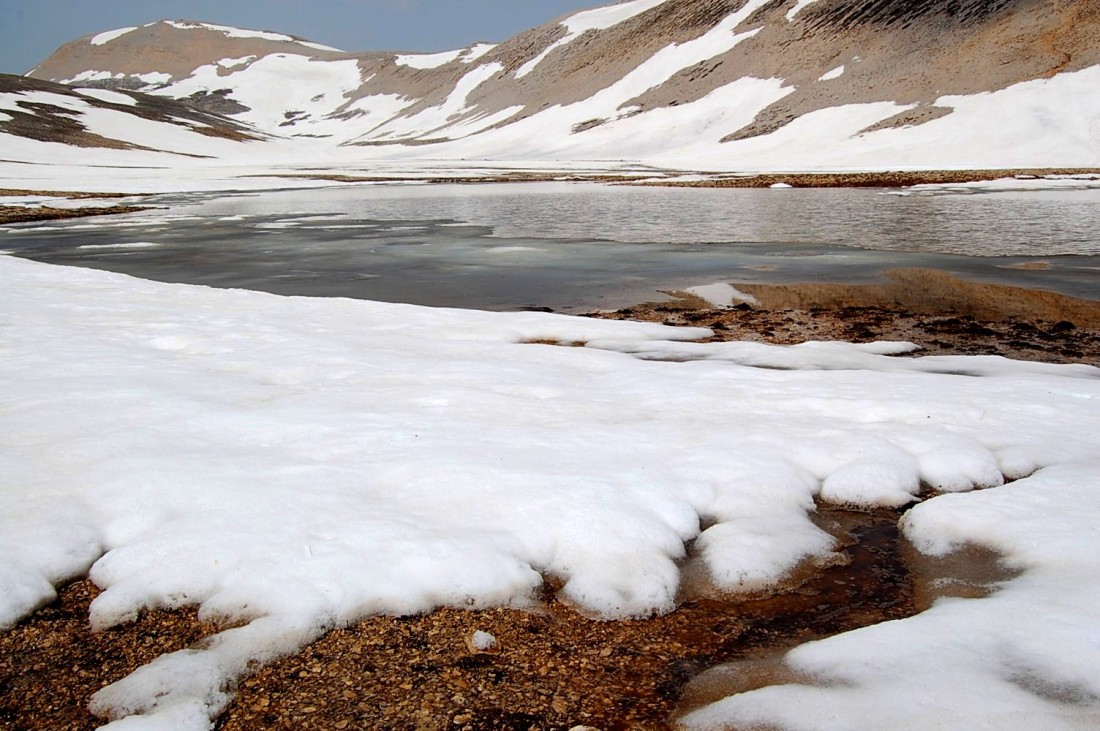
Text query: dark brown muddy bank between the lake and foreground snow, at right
587 269 1100 366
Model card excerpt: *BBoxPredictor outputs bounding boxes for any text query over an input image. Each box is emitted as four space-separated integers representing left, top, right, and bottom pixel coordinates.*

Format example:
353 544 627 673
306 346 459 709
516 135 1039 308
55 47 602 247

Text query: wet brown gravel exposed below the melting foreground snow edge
0 510 914 731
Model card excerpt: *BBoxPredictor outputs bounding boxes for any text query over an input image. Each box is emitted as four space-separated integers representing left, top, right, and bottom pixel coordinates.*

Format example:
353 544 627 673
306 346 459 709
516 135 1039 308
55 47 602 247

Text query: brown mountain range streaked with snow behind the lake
12 0 1100 169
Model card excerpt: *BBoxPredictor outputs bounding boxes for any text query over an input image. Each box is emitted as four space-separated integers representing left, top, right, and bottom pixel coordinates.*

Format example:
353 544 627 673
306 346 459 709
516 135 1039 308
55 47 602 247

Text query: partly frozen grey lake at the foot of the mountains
0 182 1100 312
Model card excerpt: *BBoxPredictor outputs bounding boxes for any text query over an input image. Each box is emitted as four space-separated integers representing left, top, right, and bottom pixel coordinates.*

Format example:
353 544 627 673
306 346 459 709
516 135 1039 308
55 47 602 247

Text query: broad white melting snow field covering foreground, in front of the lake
0 256 1100 731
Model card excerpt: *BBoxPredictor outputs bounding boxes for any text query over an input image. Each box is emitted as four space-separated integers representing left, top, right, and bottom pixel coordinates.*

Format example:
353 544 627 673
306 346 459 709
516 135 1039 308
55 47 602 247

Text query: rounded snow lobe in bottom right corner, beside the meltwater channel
686 461 1100 731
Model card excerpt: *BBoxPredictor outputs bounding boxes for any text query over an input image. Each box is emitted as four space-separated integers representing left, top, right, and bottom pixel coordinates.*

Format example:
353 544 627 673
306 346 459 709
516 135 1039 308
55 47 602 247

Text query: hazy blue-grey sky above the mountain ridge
0 0 612 74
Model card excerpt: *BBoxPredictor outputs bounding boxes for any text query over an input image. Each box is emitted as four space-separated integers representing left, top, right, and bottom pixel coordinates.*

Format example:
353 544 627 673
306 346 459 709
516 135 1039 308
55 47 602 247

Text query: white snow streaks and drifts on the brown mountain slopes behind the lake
27 0 1100 168
